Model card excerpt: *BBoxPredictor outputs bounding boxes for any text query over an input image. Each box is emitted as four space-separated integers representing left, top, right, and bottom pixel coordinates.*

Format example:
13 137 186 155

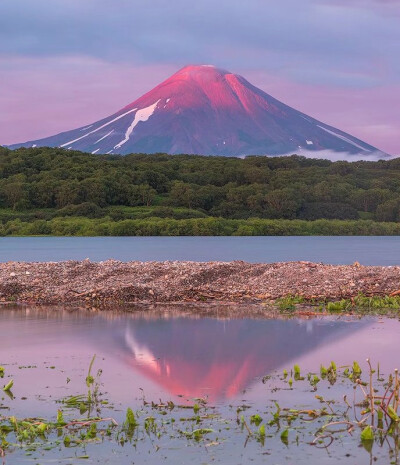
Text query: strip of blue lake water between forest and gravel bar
0 236 400 265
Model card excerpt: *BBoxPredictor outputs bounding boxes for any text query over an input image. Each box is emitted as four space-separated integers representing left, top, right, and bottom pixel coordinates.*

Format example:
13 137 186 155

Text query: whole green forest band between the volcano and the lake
0 147 400 235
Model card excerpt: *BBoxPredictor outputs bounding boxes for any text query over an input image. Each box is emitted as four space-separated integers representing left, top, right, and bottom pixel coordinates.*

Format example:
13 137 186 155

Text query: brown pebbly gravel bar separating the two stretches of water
0 260 400 307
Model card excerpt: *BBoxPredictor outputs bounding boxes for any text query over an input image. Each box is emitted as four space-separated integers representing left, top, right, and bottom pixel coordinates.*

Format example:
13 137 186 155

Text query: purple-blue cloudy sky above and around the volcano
0 0 400 155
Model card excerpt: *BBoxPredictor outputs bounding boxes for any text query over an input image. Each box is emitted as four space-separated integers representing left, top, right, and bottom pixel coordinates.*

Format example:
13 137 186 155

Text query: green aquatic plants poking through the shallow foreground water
0 358 400 464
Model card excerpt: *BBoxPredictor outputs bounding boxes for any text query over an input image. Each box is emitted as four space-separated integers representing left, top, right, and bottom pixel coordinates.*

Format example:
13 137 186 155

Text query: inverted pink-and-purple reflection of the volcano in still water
117 318 366 399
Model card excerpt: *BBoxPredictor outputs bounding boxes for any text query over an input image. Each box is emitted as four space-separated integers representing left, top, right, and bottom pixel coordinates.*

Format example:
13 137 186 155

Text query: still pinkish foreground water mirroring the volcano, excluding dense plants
0 307 400 465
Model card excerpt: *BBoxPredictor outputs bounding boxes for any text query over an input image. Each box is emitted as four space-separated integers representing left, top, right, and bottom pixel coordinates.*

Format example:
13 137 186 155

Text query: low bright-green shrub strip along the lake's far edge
0 218 400 236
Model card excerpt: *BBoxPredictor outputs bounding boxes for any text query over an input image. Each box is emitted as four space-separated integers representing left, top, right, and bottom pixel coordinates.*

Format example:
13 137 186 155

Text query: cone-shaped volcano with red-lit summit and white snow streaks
10 65 387 159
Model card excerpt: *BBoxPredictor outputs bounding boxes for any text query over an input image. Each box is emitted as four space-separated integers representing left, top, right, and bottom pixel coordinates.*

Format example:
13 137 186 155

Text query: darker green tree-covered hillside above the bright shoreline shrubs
0 148 400 226
